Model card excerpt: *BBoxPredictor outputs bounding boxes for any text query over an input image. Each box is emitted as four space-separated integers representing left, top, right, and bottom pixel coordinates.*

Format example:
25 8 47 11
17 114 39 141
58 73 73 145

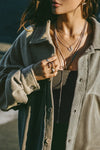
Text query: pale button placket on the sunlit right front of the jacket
66 55 88 150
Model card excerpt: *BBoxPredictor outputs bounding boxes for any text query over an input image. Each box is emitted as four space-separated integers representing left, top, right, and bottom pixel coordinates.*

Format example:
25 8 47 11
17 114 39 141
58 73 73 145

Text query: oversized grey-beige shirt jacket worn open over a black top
0 18 100 150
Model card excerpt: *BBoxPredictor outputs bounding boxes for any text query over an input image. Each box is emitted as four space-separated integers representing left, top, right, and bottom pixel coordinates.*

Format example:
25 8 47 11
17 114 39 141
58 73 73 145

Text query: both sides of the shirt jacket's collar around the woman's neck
29 17 100 50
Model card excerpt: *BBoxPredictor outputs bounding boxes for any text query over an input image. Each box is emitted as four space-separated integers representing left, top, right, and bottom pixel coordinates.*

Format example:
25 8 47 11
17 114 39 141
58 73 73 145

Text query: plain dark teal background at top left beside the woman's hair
0 0 30 43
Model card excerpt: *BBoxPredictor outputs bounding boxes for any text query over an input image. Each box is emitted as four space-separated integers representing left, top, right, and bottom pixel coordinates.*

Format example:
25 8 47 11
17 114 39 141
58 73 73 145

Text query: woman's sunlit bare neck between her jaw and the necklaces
57 9 85 37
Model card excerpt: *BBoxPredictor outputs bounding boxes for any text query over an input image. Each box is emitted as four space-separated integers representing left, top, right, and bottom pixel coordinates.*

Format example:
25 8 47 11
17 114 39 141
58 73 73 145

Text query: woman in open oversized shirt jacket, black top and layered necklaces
0 0 100 150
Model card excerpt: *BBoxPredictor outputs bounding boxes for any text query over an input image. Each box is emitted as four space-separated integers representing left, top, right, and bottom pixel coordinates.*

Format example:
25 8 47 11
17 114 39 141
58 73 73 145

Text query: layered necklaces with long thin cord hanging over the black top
54 21 87 123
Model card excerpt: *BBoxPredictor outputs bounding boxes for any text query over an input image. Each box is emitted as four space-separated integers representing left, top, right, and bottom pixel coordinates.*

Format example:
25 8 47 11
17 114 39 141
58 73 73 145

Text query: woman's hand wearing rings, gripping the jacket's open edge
33 55 59 80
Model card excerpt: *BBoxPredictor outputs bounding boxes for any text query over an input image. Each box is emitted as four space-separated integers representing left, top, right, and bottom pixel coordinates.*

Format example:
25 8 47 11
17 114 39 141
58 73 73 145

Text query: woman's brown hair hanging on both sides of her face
19 0 98 29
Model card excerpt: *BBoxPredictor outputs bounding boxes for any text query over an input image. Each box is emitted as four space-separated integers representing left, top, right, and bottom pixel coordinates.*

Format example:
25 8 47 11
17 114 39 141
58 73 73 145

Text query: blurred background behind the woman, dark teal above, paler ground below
0 0 100 150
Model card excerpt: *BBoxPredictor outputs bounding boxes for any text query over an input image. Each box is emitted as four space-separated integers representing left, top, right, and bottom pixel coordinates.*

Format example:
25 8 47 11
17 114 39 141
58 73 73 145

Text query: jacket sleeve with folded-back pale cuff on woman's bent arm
0 33 40 110
